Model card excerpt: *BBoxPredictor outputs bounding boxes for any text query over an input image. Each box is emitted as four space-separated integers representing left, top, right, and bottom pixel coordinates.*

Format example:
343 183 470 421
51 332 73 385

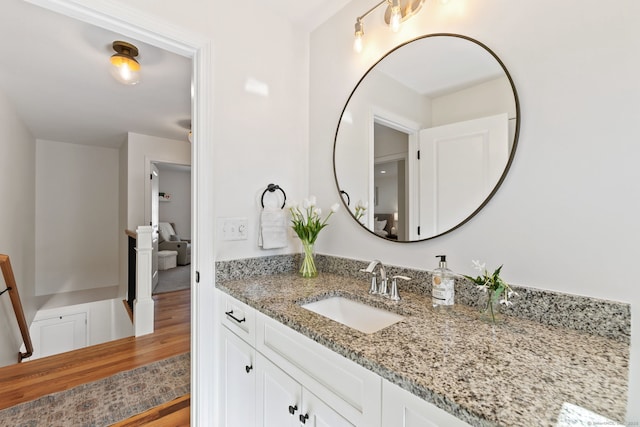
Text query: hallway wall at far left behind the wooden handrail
0 88 36 366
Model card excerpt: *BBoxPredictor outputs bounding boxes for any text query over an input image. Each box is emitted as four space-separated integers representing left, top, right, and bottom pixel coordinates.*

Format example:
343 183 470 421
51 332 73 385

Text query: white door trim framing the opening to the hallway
24 0 219 426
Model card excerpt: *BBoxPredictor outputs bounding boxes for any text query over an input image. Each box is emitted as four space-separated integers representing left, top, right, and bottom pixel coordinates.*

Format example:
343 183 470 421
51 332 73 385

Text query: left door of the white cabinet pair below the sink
256 353 302 427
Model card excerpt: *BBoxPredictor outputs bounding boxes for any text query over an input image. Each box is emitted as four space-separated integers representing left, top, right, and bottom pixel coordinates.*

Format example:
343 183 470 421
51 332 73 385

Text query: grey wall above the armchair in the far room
158 164 191 239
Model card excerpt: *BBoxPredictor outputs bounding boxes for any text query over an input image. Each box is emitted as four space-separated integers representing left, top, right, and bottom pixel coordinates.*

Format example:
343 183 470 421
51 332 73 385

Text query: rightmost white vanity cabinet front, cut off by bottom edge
382 380 470 427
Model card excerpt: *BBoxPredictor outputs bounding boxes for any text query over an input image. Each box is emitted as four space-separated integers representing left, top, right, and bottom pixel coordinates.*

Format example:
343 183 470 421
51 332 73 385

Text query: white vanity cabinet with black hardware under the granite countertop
217 290 468 427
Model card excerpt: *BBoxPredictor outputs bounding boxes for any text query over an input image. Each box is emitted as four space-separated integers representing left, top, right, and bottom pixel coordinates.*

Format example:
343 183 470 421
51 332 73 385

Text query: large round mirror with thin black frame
333 34 520 242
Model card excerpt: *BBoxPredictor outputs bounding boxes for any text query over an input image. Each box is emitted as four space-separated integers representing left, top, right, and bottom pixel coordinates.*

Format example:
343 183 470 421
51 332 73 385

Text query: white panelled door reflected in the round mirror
412 114 509 238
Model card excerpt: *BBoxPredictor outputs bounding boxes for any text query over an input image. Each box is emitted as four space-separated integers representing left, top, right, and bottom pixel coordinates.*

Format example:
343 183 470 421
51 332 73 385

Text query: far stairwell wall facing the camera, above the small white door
36 140 120 295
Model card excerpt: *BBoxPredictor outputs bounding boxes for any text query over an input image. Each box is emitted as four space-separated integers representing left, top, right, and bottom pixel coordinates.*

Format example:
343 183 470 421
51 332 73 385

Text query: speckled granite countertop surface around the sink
216 273 629 427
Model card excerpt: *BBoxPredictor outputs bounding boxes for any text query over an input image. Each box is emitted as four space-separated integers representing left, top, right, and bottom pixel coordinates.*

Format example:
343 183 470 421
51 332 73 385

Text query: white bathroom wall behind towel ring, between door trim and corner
108 0 310 260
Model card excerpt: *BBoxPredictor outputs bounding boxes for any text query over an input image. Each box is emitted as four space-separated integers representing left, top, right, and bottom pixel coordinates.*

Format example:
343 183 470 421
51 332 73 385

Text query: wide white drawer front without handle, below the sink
256 313 382 427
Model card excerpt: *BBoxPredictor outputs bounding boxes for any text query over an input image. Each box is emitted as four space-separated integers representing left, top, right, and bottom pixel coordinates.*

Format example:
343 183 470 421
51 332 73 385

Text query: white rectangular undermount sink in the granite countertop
302 297 404 334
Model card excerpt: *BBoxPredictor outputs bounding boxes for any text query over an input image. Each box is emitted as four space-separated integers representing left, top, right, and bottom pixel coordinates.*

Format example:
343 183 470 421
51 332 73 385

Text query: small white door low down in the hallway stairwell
30 313 87 360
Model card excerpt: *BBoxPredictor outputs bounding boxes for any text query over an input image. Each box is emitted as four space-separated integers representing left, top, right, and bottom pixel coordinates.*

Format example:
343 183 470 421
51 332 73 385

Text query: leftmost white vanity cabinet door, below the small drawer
220 327 256 427
